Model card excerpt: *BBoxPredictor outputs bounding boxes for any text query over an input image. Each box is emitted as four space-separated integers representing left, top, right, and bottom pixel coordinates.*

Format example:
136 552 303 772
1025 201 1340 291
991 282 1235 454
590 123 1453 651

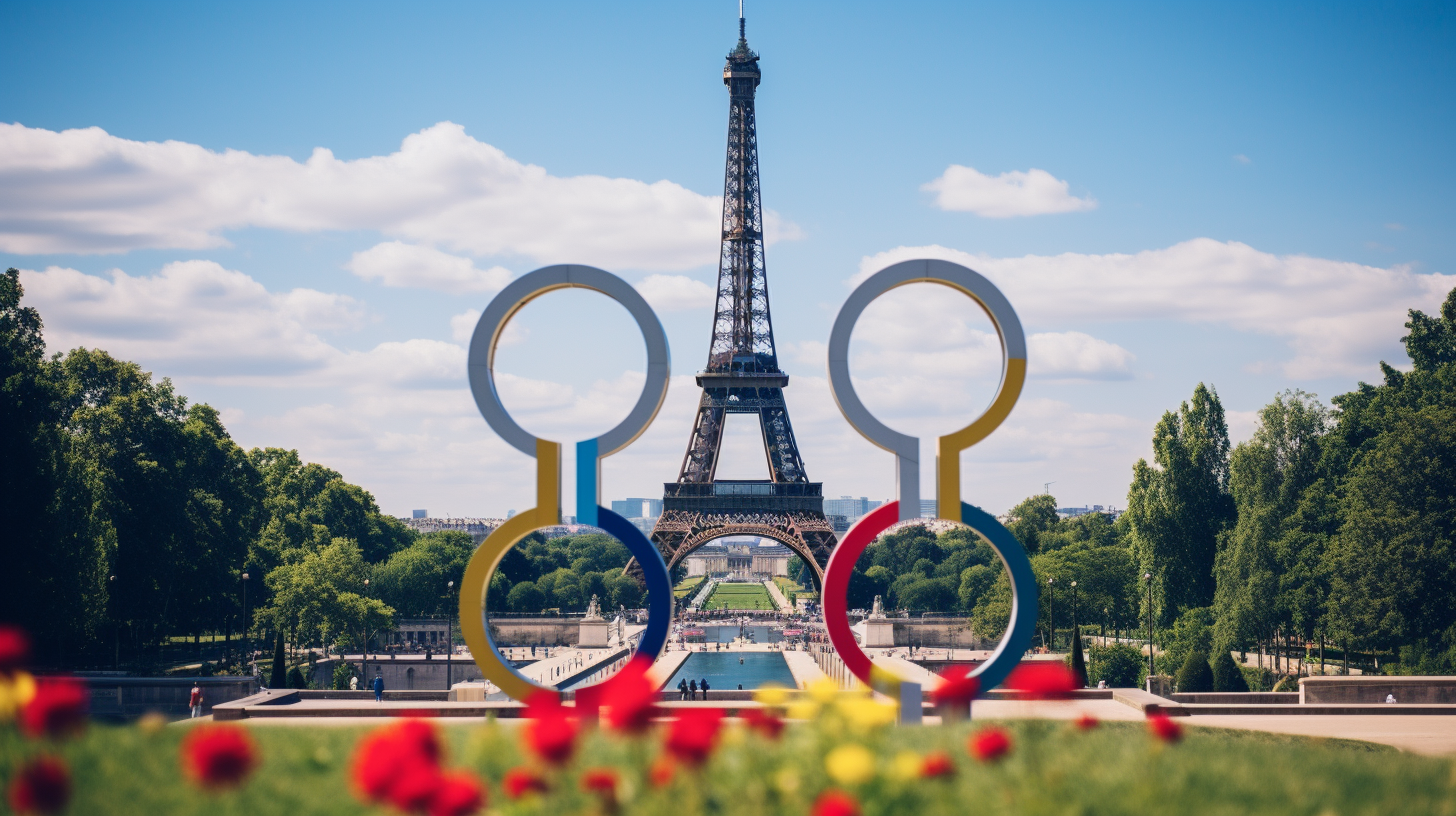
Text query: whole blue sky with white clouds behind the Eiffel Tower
0 0 1456 516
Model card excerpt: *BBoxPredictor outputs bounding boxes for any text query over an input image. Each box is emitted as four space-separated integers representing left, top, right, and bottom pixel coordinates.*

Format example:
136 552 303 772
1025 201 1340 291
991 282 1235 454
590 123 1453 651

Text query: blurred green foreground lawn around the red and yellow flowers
0 715 1456 816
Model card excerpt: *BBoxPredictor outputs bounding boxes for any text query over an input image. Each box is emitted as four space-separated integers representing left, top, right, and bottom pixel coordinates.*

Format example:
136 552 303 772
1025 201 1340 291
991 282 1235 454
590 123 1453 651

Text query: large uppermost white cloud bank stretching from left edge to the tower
0 122 798 270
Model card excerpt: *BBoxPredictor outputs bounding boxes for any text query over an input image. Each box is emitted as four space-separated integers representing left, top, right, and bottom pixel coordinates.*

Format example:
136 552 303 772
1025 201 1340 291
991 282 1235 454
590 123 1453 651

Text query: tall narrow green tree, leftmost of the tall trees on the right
1127 383 1235 625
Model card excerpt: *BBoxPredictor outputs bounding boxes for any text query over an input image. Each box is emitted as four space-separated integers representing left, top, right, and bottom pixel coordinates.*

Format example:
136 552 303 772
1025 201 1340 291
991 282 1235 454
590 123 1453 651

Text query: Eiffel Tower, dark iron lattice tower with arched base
652 7 837 583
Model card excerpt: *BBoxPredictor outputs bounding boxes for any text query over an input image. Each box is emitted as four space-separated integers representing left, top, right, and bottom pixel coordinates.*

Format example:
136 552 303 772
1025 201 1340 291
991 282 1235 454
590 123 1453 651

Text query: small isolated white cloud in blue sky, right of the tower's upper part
920 165 1096 219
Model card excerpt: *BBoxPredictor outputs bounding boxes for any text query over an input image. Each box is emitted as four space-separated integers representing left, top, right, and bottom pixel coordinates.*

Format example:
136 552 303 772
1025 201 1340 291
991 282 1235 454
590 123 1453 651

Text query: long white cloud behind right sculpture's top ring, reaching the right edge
850 238 1456 379
